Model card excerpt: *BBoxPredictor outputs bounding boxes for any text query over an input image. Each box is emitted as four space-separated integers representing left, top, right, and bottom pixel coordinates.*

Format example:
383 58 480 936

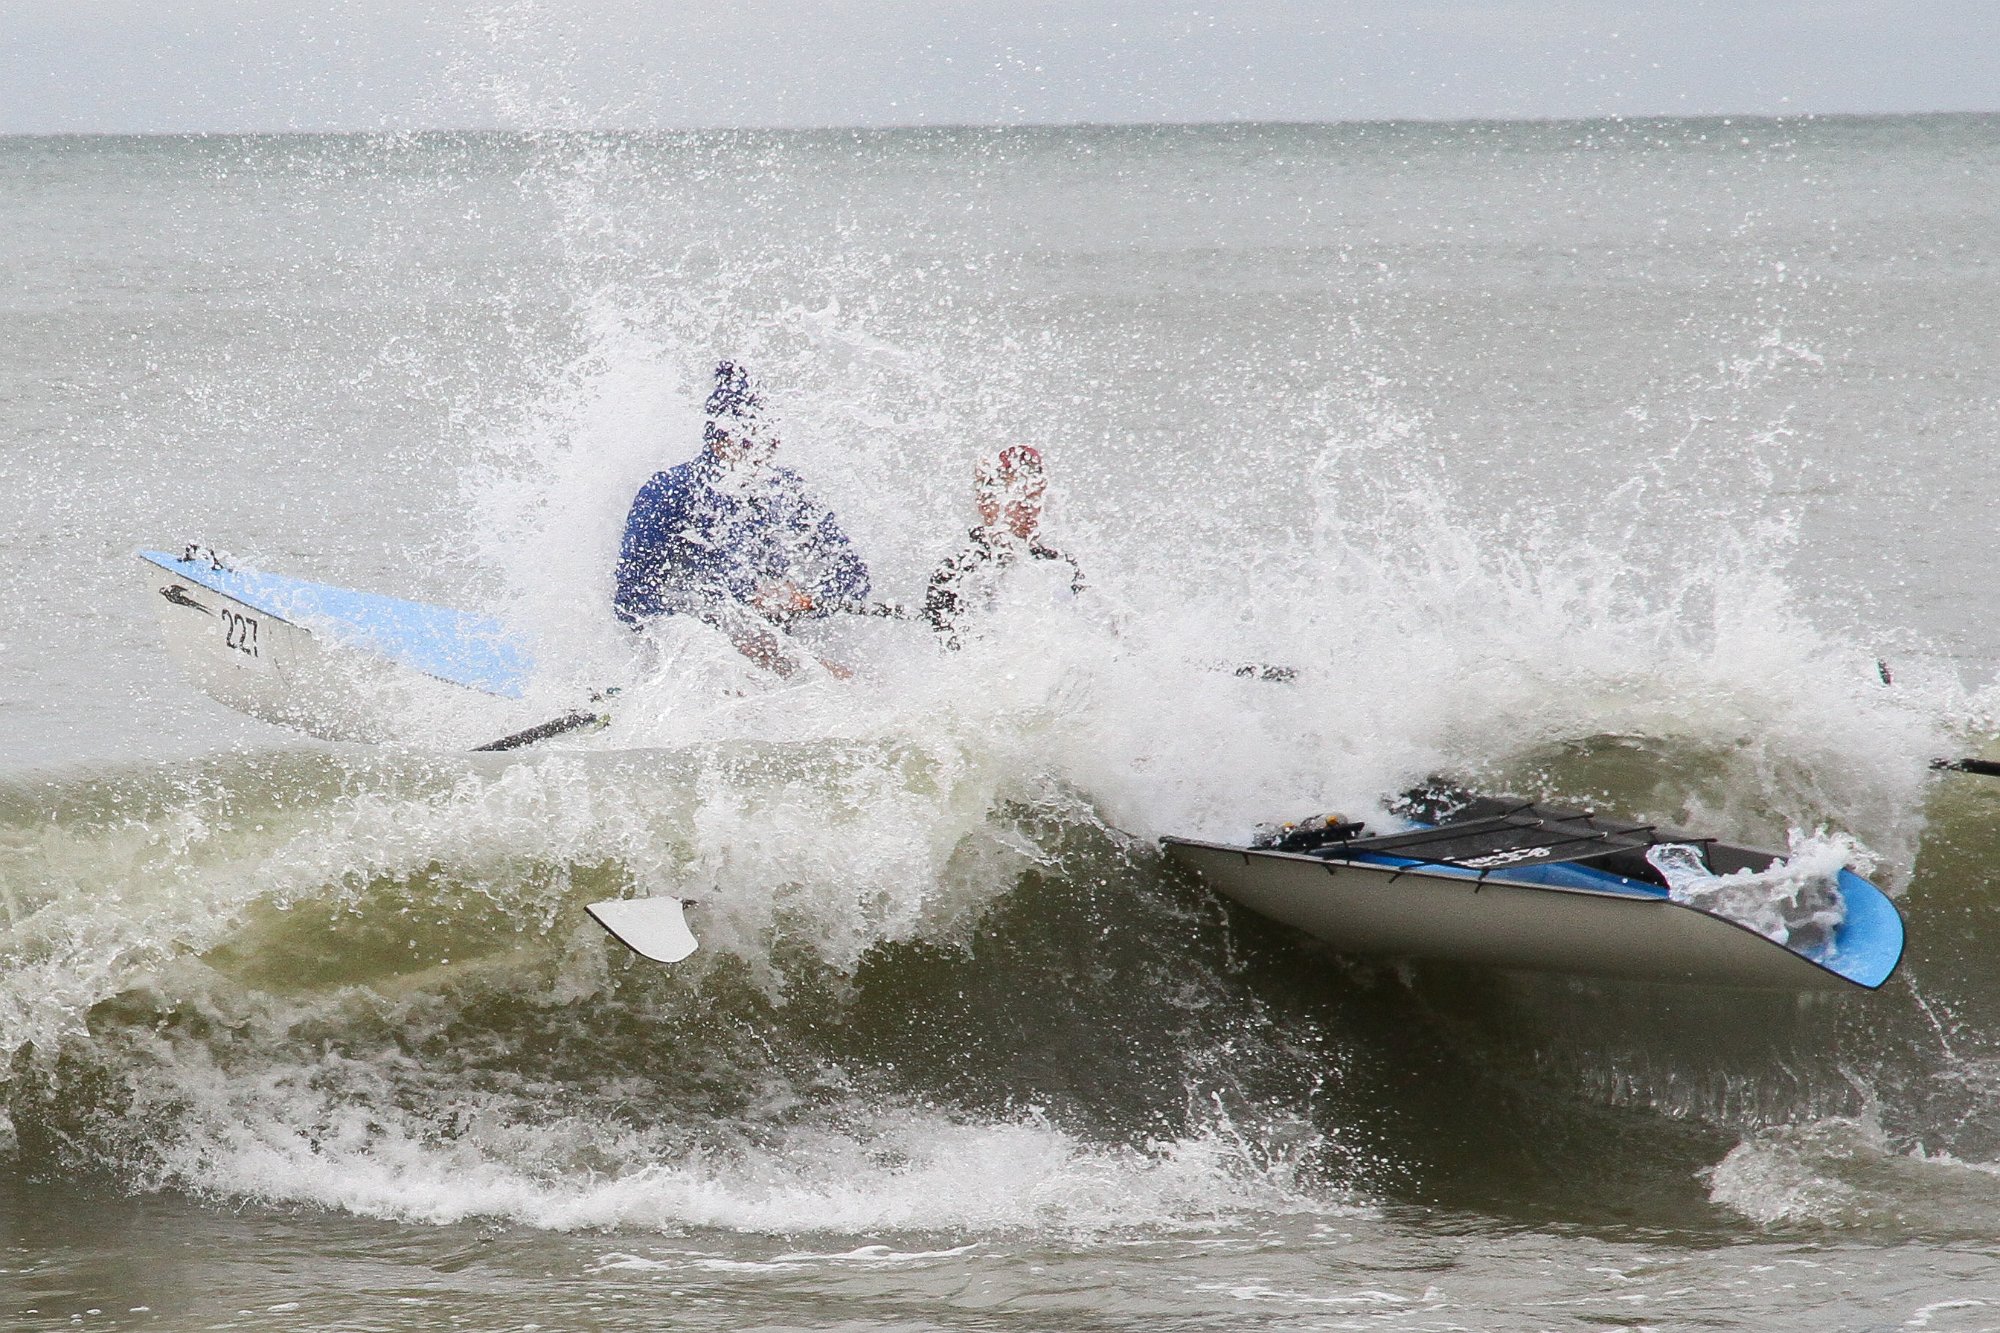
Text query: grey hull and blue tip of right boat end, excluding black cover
1162 820 1902 991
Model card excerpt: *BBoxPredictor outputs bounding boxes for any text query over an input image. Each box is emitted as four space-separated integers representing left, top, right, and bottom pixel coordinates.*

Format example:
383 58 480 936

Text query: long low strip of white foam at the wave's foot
133 1024 1352 1232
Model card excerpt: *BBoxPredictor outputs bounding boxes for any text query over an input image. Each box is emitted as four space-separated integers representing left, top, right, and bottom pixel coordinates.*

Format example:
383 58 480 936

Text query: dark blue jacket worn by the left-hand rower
612 448 868 628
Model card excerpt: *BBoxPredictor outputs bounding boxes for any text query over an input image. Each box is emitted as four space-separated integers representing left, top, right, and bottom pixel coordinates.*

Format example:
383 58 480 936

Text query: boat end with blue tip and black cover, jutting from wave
1162 797 1904 991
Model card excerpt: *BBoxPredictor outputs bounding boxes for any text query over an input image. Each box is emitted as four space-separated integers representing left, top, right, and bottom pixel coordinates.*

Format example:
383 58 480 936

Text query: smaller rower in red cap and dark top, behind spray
924 444 1084 648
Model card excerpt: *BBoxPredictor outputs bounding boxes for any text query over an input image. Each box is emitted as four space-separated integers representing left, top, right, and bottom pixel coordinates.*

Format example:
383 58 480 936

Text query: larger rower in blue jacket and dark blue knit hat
612 360 868 675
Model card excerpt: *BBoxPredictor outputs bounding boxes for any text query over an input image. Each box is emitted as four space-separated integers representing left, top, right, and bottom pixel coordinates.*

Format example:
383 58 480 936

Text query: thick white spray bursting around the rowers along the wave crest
438 272 1942 861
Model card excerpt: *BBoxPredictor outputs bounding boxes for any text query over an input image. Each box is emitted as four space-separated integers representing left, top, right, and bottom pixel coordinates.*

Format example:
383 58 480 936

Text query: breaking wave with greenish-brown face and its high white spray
15 122 2000 1235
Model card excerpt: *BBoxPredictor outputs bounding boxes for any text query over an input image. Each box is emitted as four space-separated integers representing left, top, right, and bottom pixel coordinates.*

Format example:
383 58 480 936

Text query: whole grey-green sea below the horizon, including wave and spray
0 116 2000 1329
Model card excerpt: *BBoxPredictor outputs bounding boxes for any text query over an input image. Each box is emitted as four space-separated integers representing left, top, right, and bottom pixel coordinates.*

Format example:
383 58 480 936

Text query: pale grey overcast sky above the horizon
0 0 2000 134
